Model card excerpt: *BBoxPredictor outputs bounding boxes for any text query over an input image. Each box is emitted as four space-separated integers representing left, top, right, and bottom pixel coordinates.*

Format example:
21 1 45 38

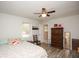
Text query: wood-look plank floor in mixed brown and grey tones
39 43 79 58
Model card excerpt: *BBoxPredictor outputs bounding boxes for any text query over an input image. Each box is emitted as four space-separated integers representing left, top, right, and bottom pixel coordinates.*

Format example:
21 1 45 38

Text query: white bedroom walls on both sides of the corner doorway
0 13 79 43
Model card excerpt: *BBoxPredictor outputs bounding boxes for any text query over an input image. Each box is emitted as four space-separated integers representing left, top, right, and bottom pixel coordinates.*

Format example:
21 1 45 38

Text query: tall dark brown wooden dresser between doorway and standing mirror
51 28 63 49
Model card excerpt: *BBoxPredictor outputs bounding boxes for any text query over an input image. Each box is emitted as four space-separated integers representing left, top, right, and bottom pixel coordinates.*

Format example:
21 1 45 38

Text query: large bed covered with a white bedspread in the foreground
0 41 47 58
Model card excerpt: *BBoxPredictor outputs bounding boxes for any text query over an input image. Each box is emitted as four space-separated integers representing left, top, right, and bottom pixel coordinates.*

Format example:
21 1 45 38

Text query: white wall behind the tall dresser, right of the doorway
44 15 79 44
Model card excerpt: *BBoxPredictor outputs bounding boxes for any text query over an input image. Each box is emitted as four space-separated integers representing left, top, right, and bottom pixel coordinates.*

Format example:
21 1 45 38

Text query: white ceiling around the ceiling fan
0 1 79 21
